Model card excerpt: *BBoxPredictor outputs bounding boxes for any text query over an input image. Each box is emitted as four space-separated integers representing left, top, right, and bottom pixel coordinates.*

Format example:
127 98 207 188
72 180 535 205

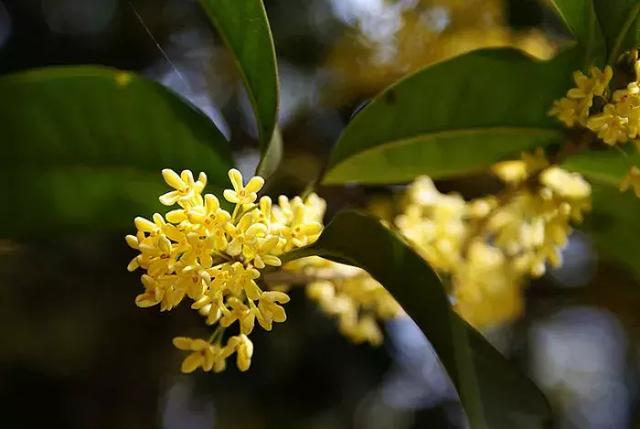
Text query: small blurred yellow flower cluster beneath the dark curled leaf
285 256 404 346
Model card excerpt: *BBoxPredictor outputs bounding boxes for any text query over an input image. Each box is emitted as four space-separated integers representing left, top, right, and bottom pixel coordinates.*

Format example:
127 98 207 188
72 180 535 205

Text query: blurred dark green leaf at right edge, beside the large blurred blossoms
583 184 640 280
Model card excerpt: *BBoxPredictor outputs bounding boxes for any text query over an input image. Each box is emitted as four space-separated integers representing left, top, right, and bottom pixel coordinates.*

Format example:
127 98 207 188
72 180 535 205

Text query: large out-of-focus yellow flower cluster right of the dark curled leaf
395 151 591 327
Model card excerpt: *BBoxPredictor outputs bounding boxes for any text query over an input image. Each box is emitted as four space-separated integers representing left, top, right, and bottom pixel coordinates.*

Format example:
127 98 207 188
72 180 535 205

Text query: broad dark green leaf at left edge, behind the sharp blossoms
0 67 231 236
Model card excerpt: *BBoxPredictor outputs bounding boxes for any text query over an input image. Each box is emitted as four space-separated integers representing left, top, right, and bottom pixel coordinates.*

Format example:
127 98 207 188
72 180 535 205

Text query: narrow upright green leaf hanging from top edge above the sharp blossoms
200 0 280 172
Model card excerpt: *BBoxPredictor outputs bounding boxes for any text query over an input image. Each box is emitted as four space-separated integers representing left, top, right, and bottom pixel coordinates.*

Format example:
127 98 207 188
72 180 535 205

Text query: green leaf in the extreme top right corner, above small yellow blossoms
594 0 640 64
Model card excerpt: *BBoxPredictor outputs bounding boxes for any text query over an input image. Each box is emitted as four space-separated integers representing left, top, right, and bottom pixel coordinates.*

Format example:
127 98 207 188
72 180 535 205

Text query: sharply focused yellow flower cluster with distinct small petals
126 169 324 372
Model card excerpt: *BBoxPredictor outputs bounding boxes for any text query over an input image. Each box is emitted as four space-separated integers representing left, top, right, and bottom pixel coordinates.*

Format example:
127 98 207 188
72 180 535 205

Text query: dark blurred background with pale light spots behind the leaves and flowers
0 0 640 429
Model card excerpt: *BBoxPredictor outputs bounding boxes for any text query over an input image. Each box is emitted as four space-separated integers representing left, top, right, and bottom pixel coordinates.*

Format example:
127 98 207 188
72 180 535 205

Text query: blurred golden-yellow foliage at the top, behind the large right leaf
327 0 557 99
